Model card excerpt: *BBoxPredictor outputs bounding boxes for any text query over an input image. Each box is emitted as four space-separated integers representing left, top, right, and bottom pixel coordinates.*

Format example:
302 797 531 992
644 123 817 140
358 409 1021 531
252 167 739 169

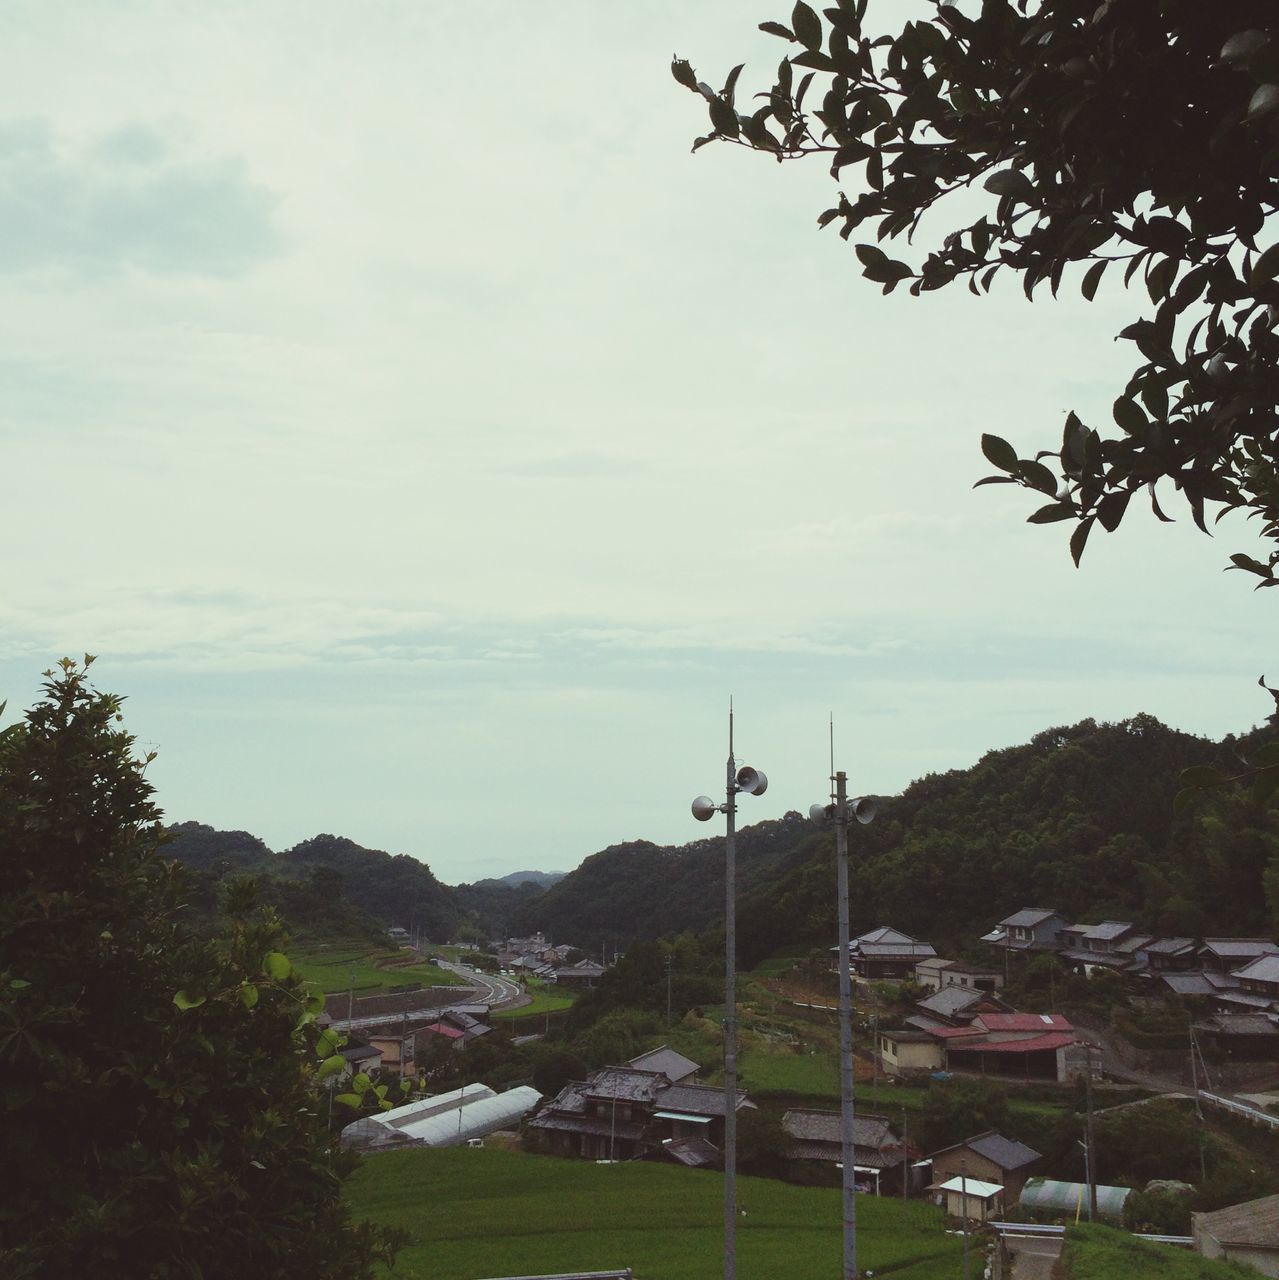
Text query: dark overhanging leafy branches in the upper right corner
672 0 1279 576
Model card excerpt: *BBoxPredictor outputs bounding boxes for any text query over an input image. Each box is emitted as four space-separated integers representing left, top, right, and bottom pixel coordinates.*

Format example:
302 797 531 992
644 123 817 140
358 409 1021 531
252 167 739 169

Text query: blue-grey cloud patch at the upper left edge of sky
0 120 280 276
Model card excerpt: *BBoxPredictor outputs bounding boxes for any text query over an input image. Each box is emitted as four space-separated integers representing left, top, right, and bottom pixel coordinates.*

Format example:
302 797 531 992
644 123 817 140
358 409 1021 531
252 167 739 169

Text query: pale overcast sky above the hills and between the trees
0 0 1279 883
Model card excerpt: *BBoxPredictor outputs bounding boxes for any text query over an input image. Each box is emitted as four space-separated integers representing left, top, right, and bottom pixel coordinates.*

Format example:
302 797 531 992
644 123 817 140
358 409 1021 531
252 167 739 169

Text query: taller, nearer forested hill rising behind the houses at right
739 716 1279 955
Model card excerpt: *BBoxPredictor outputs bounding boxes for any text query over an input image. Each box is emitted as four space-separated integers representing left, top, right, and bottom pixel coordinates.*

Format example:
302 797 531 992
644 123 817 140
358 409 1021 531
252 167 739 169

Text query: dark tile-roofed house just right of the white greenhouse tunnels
529 1050 754 1160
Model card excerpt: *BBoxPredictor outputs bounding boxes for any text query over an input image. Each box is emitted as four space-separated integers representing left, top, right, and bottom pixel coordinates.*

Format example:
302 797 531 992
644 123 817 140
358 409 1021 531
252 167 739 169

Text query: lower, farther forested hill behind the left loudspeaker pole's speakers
511 813 821 950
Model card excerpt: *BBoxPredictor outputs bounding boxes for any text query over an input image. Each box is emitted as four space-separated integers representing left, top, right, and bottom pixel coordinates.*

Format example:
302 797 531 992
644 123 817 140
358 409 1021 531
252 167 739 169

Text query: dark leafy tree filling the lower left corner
0 659 390 1280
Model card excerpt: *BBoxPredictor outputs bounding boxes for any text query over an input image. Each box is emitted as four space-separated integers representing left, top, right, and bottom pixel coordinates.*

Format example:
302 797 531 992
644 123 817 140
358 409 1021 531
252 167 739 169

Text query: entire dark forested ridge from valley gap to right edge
513 716 1279 959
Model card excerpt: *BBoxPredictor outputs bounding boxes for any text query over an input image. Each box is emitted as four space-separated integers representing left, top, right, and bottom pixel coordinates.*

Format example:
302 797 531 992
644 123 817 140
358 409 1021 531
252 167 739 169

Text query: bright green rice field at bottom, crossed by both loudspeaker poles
347 1148 962 1280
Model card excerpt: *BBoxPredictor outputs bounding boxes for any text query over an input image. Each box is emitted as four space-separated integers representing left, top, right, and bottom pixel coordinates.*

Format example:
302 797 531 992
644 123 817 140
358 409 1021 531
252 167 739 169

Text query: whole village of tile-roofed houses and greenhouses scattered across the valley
325 908 1279 1275
